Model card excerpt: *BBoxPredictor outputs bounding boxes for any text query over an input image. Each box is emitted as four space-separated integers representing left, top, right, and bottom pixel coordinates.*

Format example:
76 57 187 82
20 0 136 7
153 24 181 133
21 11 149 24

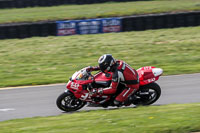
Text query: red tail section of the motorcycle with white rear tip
137 66 163 86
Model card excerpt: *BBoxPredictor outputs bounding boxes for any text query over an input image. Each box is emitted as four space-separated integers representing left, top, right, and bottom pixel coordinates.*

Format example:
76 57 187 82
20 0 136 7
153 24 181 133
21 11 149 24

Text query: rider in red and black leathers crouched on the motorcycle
86 54 139 105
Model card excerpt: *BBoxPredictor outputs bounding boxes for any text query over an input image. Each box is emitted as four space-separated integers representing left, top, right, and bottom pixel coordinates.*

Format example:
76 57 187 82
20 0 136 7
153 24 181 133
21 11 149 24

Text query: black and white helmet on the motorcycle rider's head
98 54 115 72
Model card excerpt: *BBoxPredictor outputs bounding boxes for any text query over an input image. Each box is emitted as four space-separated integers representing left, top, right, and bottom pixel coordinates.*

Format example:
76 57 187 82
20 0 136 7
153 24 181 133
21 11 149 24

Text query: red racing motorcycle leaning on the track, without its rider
56 66 163 112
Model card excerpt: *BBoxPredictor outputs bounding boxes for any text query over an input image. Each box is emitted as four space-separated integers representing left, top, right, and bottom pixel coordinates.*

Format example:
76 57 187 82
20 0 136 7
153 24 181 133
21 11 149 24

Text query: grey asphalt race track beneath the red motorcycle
0 73 200 121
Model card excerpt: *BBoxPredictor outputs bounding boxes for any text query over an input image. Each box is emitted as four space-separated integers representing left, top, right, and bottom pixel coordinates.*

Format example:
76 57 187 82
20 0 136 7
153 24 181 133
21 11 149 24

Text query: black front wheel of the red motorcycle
56 91 86 112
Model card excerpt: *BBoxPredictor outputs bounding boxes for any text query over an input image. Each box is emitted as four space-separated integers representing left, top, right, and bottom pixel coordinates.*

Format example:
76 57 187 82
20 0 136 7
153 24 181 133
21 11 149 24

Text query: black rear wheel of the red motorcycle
133 82 161 105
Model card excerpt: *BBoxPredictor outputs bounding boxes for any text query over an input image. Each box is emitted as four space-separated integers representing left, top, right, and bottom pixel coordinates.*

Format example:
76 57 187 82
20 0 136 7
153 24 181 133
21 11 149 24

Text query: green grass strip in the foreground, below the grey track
0 103 200 133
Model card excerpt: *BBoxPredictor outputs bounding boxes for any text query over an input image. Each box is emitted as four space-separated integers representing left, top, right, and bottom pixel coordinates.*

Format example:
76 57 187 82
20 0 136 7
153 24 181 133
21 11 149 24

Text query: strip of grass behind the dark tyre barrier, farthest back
0 0 200 23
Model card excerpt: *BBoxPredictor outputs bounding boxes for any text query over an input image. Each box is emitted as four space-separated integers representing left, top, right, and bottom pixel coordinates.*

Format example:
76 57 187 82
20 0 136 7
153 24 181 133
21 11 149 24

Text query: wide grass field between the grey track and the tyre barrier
0 27 200 87
